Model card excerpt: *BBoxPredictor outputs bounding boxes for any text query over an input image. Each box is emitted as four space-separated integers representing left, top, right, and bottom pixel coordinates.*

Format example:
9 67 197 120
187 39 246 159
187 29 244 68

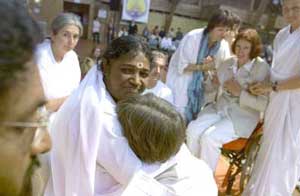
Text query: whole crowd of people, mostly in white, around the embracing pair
0 0 300 196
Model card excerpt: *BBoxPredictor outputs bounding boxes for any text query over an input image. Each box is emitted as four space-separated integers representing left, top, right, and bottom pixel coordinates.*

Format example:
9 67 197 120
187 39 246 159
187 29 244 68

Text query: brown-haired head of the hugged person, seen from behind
117 93 185 163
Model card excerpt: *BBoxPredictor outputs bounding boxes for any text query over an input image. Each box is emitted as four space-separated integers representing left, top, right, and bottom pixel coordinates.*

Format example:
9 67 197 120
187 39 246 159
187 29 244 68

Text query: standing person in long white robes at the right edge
243 0 300 196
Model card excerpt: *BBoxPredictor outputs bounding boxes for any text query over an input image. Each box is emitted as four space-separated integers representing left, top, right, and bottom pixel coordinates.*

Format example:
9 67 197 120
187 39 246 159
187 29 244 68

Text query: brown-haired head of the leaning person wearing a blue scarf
205 10 233 42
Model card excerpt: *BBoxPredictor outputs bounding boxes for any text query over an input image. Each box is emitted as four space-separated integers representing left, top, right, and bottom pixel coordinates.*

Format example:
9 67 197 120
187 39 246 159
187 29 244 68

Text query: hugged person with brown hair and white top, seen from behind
117 93 218 196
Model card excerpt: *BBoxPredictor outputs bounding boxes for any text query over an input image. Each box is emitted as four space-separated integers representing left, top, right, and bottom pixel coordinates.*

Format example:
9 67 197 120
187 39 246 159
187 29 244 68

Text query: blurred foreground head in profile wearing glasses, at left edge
0 0 48 196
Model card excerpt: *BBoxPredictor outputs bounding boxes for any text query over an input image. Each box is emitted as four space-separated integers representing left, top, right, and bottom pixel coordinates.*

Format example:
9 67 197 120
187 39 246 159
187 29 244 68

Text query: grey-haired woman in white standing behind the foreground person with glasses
36 13 83 112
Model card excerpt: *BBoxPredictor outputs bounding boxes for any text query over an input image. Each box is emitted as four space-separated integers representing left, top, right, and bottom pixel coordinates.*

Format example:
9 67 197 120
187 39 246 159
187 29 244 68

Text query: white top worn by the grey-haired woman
36 39 81 100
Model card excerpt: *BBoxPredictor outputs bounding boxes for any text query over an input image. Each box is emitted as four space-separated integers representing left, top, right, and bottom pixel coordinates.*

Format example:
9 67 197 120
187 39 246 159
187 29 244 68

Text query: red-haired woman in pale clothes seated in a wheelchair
187 29 269 170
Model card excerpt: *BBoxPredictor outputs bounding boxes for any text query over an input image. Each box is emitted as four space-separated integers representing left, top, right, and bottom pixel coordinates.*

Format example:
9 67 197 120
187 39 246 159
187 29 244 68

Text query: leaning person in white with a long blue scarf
167 10 232 122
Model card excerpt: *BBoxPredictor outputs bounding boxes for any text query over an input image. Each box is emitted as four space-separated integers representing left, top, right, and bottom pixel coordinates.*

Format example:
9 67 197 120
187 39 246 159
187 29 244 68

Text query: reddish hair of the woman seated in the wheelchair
231 29 262 59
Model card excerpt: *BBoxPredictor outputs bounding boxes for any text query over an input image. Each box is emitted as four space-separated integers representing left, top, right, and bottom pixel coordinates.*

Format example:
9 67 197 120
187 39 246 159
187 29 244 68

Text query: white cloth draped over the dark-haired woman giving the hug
45 66 217 196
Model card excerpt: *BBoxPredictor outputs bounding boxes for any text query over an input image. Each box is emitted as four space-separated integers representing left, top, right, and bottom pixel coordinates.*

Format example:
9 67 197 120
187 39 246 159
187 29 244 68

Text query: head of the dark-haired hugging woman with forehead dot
102 35 152 102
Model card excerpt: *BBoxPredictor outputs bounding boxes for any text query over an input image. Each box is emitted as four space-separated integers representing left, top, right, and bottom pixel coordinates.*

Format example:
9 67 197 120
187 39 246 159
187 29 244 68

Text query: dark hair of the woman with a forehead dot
102 35 153 68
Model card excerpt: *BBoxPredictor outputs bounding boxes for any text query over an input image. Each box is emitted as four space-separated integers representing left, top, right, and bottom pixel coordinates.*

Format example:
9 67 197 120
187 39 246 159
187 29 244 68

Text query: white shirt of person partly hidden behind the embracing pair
143 80 174 104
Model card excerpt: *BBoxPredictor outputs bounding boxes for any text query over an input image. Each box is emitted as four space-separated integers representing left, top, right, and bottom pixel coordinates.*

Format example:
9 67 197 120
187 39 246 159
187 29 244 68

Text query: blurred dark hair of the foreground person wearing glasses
0 0 42 93
